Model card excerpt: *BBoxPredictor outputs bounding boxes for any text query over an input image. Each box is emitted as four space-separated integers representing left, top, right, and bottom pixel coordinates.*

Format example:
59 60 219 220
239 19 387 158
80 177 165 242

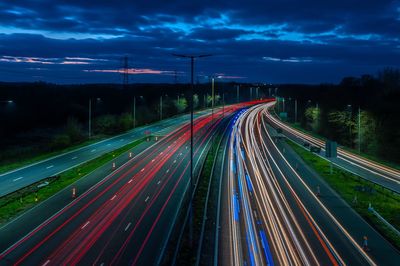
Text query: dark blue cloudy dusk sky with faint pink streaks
0 0 400 83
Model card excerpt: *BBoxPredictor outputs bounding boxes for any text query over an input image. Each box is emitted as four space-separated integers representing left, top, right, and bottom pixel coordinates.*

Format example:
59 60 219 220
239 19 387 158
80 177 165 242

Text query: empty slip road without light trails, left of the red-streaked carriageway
0 110 210 197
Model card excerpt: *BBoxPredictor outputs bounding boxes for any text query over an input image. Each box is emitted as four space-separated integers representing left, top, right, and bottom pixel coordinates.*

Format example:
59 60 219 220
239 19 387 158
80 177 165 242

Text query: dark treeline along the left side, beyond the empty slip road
0 82 265 161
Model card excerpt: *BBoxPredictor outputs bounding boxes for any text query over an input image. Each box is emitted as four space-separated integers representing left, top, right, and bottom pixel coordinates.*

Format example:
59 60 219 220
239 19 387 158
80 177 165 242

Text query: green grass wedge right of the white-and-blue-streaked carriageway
286 140 400 249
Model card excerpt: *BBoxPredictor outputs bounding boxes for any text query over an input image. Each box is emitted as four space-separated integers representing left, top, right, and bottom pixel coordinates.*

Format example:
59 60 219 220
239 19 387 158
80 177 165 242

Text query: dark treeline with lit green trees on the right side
277 68 400 163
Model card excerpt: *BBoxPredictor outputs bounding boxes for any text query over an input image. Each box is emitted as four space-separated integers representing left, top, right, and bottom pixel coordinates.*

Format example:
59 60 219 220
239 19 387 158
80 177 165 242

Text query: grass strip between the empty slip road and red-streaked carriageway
0 138 145 225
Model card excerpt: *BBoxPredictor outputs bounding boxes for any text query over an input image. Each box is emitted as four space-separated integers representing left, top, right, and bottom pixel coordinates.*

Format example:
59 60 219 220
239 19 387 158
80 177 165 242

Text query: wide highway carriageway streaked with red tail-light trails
0 105 250 265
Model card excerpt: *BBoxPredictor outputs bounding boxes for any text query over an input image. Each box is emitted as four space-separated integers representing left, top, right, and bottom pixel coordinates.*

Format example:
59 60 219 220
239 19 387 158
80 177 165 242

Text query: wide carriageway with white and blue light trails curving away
218 103 400 265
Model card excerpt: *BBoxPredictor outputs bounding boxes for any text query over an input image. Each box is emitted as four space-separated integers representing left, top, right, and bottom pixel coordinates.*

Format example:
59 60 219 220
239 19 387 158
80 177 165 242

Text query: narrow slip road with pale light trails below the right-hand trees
265 102 400 193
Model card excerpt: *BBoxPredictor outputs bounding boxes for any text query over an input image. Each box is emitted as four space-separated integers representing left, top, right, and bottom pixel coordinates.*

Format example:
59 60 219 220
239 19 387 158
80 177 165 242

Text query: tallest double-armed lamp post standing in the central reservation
172 54 211 245
